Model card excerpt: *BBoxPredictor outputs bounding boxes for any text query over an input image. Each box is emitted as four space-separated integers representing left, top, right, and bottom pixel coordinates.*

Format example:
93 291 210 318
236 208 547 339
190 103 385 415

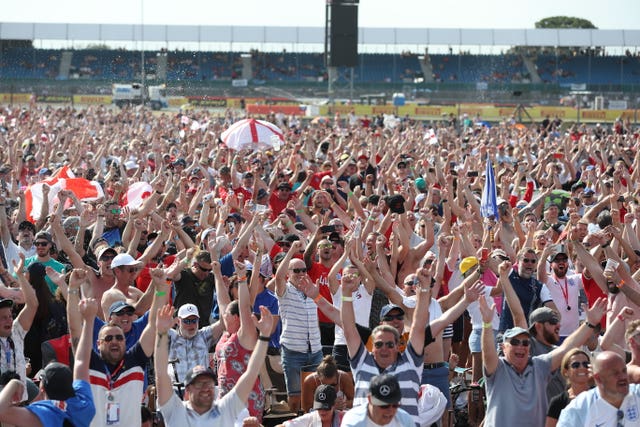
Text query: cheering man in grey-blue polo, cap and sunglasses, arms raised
479 296 607 427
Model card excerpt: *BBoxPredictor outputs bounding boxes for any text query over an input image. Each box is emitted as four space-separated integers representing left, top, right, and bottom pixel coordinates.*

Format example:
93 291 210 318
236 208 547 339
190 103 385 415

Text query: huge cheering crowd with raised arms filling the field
0 105 640 427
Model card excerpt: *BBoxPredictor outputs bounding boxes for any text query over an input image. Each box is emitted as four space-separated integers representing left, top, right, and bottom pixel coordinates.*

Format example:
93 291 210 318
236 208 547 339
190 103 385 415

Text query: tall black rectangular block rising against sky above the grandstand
329 2 358 67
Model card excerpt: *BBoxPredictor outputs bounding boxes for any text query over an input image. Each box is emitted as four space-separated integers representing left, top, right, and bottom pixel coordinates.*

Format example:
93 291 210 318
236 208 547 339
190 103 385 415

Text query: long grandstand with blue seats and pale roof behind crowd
0 23 640 101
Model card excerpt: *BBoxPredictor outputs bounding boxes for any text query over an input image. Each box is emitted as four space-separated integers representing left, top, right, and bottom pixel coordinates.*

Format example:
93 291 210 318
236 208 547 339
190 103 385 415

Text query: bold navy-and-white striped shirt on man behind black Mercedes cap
349 343 423 426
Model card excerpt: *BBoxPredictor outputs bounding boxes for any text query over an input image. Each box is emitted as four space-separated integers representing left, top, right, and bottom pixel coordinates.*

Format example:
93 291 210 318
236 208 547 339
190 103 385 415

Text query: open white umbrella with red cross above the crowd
220 119 284 151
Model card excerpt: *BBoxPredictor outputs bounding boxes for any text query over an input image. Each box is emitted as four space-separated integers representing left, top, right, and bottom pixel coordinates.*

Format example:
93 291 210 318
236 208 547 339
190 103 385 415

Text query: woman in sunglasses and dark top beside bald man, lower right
545 348 593 427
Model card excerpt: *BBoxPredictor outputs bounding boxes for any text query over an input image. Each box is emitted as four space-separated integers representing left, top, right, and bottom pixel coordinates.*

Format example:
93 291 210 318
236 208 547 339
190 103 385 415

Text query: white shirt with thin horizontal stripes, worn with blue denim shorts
278 282 322 353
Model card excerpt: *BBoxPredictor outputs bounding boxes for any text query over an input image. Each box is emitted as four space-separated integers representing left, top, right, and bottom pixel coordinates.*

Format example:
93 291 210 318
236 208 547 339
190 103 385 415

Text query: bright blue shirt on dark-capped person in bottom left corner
27 380 96 427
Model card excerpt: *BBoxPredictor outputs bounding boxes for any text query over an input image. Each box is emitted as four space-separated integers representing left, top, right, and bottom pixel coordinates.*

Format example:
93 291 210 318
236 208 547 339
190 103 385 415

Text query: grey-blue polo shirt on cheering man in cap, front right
483 354 551 427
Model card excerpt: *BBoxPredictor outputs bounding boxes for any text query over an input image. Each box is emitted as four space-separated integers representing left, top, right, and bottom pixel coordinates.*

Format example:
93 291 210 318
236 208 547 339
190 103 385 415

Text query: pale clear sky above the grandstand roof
1 0 640 30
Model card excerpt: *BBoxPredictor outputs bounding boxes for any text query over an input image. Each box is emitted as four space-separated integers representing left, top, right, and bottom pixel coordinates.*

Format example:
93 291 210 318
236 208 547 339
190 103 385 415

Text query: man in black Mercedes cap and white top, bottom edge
340 374 416 427
